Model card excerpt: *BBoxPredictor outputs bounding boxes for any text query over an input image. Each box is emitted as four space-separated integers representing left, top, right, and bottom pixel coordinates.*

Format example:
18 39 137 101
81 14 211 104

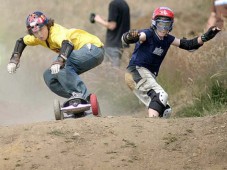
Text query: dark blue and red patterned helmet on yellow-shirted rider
26 11 48 33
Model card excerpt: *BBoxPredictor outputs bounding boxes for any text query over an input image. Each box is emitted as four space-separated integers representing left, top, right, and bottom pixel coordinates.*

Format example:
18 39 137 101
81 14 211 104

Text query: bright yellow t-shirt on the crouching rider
23 23 103 52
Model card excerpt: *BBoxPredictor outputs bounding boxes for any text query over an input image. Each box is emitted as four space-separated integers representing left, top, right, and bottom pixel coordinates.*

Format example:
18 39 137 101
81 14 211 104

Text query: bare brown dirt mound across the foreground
0 113 227 170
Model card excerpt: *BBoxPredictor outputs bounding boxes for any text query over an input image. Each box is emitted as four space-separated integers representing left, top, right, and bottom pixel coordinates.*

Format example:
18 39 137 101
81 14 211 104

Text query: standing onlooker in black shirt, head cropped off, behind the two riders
91 0 130 67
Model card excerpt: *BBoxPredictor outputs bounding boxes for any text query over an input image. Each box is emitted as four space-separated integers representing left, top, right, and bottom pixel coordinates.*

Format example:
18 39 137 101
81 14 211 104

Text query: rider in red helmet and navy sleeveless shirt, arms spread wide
122 7 220 118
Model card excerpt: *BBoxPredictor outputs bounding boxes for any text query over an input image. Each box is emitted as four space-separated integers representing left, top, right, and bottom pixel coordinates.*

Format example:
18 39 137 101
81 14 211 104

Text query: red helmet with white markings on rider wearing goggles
152 7 174 31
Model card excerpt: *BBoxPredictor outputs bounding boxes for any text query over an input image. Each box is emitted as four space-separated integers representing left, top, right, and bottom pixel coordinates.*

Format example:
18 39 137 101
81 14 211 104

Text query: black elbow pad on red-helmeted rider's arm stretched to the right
179 37 203 50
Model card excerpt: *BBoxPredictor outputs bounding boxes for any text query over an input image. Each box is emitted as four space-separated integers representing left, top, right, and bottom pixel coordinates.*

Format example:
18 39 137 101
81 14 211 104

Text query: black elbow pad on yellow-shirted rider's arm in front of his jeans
59 40 74 60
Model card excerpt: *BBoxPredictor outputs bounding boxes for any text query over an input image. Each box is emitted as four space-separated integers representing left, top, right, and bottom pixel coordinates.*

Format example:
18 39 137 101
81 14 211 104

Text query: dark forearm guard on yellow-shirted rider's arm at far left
10 38 27 64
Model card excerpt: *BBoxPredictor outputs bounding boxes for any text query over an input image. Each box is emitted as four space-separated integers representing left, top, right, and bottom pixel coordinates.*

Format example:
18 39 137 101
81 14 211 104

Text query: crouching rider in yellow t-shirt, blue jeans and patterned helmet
7 11 104 101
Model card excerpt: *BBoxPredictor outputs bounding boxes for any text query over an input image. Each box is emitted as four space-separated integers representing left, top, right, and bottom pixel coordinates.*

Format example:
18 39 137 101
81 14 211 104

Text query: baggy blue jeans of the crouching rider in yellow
43 45 104 99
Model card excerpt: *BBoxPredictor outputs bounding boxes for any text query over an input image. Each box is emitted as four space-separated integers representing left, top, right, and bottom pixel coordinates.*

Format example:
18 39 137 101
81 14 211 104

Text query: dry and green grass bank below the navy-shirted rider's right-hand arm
159 32 227 117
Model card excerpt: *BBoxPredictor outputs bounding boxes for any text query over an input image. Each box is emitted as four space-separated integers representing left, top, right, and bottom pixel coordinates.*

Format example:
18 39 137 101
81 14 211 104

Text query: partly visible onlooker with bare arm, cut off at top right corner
207 0 227 29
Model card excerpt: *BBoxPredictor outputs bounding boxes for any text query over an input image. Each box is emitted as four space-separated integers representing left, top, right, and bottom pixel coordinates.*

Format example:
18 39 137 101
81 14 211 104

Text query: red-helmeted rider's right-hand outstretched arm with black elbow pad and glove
172 26 221 50
